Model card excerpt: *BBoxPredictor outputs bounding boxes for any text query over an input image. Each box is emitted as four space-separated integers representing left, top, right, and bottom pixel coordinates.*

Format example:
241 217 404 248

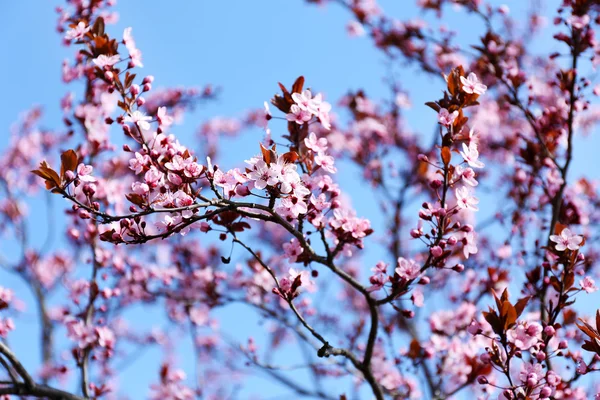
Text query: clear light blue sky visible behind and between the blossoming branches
0 0 600 399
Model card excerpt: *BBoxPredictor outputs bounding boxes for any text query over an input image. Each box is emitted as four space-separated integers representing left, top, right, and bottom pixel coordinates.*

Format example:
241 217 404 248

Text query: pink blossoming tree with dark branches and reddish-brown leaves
0 0 600 400
